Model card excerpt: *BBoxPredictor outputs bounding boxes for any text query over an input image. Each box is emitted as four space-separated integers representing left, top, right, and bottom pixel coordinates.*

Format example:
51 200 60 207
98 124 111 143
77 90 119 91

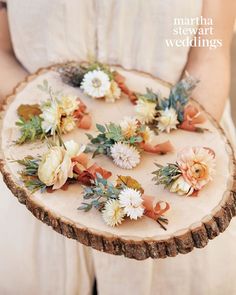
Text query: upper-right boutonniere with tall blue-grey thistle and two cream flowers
135 76 205 133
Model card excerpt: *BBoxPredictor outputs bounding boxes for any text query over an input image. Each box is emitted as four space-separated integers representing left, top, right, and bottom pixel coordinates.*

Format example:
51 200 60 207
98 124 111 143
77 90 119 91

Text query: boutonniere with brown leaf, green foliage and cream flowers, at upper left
16 80 92 144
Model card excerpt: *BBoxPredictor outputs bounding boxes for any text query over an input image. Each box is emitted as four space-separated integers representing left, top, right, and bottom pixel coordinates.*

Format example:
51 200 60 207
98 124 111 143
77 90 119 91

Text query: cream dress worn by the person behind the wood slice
0 0 236 295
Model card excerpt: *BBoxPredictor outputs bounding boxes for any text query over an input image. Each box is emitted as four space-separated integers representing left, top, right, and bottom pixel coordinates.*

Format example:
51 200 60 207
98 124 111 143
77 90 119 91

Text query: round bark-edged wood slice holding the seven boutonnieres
0 66 236 260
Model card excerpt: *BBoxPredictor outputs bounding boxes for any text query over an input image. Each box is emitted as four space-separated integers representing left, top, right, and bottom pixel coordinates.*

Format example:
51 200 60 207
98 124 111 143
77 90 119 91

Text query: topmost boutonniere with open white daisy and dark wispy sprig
59 62 135 102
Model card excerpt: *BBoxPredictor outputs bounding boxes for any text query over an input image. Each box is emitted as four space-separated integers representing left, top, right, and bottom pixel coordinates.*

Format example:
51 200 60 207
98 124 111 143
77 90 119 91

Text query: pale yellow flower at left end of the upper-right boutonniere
135 99 156 123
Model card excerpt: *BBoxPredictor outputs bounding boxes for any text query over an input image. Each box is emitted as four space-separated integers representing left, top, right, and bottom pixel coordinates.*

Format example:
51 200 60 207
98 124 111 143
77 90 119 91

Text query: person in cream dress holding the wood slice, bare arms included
0 0 236 295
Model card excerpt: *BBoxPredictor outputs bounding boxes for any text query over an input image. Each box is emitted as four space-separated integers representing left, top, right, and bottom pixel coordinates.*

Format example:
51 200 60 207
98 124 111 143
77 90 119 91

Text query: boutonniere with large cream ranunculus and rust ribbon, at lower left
17 140 111 192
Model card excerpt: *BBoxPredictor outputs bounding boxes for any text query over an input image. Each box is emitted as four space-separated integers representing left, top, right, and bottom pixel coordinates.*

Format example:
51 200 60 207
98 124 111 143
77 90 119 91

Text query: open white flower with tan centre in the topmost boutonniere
80 70 111 98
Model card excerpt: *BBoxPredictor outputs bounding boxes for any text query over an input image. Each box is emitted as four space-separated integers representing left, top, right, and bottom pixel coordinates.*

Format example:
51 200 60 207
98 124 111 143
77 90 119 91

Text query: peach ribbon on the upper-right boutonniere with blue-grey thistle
178 105 206 131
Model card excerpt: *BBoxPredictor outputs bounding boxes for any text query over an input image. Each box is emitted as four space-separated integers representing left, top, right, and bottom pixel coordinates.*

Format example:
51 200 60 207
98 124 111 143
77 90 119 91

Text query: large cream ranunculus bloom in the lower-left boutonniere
38 147 73 189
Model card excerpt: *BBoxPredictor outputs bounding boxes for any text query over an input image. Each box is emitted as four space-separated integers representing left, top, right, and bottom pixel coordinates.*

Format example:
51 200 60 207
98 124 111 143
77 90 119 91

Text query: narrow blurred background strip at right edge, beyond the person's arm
230 22 236 125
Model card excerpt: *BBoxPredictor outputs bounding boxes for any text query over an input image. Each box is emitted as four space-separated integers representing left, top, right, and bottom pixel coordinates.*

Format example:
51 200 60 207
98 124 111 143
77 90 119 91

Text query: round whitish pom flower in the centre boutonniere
111 142 140 169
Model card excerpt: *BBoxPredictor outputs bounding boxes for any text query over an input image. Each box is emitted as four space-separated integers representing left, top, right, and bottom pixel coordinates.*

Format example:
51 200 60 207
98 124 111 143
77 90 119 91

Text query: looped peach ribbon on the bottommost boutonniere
142 195 170 220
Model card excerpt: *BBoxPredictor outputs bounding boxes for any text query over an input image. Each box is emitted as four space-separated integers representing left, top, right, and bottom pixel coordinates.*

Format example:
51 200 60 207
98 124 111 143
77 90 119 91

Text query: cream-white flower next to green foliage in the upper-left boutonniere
40 101 61 134
